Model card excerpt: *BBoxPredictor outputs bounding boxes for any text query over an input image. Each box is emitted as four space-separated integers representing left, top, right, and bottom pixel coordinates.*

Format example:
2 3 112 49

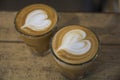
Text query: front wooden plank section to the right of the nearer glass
83 45 120 80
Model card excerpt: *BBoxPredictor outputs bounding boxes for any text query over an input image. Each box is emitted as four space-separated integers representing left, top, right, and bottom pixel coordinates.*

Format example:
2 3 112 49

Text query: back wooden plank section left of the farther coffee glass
0 12 20 41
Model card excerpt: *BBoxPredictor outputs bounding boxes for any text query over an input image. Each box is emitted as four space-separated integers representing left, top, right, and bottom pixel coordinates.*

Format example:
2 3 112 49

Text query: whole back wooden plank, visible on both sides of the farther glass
0 12 120 44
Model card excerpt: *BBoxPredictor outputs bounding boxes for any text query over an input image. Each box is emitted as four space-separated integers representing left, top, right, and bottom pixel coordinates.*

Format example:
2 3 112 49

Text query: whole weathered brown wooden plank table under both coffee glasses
0 12 120 80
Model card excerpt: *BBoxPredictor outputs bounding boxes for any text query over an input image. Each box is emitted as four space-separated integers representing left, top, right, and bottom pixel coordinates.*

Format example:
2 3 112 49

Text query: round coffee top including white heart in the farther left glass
15 4 57 36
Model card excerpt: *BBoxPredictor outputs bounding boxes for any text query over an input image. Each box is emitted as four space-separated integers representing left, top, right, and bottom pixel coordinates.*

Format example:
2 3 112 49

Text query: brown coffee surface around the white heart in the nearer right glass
52 25 99 64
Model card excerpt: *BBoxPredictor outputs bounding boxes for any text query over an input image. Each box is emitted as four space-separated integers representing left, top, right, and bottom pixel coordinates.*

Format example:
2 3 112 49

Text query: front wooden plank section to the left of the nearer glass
0 43 65 80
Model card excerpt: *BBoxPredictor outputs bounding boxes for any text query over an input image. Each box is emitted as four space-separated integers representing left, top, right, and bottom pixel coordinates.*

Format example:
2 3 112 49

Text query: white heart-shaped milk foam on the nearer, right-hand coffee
57 30 91 55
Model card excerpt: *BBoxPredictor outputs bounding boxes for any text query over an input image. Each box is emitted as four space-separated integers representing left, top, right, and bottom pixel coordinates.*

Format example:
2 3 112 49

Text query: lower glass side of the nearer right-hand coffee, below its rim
54 52 93 80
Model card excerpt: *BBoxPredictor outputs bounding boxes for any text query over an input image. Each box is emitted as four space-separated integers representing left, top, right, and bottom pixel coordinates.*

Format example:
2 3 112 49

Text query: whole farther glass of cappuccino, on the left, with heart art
15 4 57 55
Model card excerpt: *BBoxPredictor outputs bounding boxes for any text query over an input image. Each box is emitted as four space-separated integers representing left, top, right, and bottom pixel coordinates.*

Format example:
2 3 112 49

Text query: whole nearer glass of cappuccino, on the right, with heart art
52 25 99 79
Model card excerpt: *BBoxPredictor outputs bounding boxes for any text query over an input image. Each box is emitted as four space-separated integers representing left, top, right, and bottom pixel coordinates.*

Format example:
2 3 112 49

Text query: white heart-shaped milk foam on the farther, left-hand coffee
21 9 52 31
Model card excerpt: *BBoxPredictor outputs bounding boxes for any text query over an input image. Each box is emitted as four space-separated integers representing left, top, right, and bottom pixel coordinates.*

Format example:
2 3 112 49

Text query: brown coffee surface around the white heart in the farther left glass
15 4 57 36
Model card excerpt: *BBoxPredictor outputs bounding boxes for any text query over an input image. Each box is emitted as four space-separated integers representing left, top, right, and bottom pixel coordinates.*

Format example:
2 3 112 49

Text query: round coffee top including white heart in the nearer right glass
52 25 99 64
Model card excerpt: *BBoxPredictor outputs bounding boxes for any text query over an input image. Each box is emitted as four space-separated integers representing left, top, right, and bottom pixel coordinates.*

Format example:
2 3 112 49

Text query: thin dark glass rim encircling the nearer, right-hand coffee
50 25 101 66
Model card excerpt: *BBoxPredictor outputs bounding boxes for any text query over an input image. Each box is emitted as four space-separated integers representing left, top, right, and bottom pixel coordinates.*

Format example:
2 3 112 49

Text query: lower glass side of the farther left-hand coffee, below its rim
21 31 54 56
